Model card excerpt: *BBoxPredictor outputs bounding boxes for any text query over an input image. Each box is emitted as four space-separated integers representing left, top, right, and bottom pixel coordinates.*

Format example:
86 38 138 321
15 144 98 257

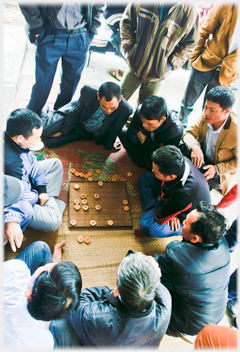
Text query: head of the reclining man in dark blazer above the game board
97 82 122 115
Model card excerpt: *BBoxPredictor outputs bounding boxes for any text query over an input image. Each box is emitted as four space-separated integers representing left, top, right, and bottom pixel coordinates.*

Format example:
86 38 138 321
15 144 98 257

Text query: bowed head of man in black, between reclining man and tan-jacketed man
140 95 167 131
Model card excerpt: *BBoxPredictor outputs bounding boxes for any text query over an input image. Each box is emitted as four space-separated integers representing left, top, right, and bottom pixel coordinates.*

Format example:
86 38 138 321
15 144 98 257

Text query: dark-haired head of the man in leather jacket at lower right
182 201 227 245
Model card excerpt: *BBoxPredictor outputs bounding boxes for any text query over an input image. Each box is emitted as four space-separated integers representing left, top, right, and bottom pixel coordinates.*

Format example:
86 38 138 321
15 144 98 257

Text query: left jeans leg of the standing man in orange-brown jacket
179 67 215 128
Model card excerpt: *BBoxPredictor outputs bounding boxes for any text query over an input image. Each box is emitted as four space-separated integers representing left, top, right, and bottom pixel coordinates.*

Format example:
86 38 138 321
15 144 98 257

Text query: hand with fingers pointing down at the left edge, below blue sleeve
4 221 23 252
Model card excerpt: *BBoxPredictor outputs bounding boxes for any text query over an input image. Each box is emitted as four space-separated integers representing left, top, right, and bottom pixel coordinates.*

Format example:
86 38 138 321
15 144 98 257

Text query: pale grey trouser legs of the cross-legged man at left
29 159 66 232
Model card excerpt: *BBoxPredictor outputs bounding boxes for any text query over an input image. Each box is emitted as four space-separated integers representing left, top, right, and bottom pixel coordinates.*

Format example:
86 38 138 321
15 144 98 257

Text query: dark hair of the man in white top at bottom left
27 260 82 321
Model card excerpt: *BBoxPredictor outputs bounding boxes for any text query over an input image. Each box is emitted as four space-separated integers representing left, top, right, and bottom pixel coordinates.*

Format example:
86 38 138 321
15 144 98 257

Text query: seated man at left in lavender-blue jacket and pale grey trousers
3 109 66 252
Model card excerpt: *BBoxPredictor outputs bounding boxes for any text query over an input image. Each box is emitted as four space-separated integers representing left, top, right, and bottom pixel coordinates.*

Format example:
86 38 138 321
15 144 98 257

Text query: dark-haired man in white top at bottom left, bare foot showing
2 241 82 351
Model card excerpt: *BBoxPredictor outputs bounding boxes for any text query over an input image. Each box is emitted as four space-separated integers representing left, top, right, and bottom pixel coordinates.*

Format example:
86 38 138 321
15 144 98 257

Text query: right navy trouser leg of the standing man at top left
54 30 92 110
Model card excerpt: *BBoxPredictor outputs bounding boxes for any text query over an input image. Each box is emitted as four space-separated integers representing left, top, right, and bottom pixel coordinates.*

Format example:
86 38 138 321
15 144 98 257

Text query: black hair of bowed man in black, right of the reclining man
140 95 167 121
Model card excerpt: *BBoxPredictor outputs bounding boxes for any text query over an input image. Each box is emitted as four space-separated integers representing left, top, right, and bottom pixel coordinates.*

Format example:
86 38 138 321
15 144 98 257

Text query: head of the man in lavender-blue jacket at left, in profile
6 109 42 149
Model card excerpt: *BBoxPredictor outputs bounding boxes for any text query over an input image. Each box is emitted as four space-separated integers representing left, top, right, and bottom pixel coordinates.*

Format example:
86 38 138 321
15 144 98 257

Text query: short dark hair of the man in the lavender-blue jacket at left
6 109 42 139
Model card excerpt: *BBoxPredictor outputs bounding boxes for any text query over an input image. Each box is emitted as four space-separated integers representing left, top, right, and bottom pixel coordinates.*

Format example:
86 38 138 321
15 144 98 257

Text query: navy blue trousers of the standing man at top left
27 25 91 114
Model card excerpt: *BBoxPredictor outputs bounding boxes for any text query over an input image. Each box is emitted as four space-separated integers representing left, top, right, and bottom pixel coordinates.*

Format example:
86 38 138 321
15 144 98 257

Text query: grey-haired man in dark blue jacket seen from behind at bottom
49 251 171 348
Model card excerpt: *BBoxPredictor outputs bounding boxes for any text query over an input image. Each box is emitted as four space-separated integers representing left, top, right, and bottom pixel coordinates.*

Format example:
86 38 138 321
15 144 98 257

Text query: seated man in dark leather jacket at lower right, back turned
154 201 230 336
